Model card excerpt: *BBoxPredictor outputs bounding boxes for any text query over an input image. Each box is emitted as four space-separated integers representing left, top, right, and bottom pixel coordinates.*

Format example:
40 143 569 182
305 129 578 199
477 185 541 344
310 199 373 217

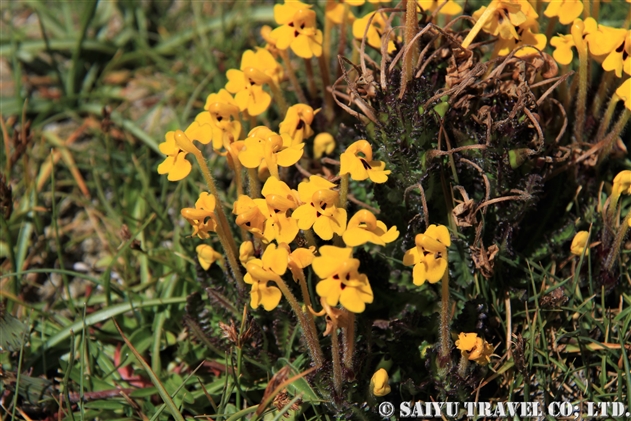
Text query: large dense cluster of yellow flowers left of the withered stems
158 1 414 312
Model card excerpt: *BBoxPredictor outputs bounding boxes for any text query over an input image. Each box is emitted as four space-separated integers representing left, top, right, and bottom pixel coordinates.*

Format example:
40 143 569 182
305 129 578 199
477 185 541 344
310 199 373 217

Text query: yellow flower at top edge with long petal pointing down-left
462 0 539 48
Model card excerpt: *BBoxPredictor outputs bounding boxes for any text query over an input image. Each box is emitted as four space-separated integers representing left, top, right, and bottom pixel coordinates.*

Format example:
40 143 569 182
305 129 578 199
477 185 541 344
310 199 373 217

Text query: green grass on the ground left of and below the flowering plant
0 1 631 421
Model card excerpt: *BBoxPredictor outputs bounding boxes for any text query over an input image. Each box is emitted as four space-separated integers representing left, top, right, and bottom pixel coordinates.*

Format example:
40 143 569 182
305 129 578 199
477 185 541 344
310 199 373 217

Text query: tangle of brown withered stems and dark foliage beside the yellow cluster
334 18 624 286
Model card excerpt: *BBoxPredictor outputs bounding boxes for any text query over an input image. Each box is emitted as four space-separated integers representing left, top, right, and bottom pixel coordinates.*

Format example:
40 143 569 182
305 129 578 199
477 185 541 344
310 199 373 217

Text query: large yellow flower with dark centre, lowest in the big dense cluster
312 246 373 313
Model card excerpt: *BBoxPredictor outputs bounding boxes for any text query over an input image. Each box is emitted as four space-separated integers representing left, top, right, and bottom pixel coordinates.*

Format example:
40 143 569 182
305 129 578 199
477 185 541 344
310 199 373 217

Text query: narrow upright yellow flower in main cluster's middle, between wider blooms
261 176 299 243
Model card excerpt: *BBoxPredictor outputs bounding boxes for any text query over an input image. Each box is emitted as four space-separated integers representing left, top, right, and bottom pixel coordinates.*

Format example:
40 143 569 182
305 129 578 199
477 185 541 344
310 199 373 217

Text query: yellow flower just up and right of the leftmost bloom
204 89 241 151
